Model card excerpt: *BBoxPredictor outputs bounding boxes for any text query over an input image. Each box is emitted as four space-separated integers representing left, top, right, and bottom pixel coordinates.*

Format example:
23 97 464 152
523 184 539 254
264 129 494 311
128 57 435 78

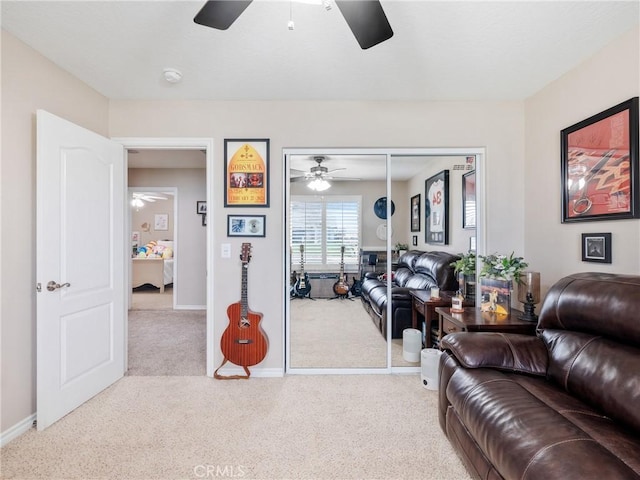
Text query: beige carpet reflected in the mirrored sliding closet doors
290 298 420 368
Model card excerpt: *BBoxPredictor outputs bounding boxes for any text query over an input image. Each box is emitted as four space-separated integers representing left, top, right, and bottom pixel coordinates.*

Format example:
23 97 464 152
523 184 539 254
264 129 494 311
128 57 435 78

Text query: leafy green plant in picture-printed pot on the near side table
479 252 529 314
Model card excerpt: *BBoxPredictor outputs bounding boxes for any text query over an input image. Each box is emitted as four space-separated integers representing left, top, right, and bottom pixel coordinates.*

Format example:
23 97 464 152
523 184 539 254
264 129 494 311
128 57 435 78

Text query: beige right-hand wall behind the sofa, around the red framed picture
524 29 640 291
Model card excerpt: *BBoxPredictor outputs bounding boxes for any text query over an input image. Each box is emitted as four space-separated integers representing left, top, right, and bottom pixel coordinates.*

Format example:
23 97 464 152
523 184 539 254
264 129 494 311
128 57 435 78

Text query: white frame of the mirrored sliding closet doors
282 147 486 375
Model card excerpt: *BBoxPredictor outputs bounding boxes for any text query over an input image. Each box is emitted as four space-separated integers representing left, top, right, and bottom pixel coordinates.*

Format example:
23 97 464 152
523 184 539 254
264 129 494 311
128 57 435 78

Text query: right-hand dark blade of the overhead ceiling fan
336 0 393 50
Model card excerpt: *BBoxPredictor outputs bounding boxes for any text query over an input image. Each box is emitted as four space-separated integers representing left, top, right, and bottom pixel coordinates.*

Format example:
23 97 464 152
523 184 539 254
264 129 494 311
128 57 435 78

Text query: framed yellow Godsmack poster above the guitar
224 138 269 207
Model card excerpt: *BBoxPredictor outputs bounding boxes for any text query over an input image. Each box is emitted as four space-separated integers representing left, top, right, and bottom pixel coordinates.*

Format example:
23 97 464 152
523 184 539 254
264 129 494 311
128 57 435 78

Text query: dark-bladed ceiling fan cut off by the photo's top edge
193 0 393 50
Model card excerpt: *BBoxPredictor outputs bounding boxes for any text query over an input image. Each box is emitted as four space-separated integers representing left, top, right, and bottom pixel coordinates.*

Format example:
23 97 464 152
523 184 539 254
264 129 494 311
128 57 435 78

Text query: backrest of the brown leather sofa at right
538 273 640 432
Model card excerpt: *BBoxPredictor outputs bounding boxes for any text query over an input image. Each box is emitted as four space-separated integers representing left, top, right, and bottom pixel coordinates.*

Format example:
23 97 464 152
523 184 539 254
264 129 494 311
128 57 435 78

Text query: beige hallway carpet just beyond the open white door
127 310 207 376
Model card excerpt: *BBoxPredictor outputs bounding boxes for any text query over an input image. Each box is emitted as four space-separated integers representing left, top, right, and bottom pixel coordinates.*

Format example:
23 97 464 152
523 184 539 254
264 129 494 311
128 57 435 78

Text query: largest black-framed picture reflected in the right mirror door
424 170 449 245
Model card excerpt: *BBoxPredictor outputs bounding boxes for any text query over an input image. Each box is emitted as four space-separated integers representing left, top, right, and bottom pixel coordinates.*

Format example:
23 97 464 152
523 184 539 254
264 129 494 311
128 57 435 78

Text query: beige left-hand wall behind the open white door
0 30 109 432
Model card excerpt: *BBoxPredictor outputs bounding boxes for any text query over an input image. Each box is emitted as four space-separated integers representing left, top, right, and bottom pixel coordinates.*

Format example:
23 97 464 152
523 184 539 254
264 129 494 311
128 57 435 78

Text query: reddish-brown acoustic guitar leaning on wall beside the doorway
214 243 269 379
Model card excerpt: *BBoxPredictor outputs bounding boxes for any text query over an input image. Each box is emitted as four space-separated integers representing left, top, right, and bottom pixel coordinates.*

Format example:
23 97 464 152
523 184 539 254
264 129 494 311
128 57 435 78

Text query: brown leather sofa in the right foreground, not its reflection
439 273 640 480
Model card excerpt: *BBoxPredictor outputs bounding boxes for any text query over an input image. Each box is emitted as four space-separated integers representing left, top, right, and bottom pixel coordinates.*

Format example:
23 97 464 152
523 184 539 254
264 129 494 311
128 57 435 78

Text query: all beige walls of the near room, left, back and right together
1 24 640 438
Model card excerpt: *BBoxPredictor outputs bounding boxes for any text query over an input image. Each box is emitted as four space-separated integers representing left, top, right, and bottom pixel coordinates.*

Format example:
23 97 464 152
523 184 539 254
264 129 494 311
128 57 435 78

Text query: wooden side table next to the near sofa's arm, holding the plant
435 307 538 348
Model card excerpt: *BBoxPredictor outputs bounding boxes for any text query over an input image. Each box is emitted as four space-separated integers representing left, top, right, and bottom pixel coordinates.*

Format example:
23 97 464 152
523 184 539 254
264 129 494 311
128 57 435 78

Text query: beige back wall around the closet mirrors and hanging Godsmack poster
109 101 524 371
